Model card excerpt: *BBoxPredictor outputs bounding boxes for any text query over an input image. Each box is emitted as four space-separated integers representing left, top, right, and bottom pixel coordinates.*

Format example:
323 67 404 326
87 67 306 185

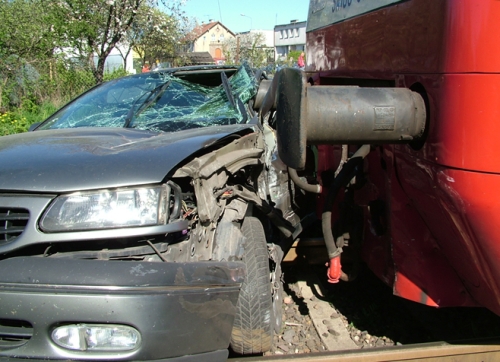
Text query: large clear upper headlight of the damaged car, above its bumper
40 186 165 232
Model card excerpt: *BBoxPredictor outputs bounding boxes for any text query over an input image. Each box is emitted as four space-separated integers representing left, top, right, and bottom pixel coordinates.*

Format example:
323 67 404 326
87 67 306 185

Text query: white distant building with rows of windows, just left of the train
274 20 307 61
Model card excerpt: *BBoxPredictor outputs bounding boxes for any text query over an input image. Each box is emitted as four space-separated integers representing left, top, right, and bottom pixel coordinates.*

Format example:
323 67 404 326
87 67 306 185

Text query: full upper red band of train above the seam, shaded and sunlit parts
306 0 500 78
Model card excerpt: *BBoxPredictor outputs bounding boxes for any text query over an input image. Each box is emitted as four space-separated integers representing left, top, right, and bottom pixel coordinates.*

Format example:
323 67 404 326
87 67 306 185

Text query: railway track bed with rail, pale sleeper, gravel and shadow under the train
229 240 500 362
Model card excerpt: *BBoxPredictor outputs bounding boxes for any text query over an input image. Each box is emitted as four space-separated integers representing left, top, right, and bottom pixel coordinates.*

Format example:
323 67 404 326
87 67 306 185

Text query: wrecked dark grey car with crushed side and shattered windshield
0 66 306 361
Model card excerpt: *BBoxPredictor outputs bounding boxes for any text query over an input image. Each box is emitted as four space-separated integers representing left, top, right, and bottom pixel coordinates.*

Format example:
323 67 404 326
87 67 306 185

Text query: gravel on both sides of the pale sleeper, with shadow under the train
266 265 500 355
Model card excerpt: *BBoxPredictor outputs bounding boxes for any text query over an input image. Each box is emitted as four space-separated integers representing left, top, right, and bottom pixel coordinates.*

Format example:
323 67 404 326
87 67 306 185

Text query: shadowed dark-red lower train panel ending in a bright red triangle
363 146 477 307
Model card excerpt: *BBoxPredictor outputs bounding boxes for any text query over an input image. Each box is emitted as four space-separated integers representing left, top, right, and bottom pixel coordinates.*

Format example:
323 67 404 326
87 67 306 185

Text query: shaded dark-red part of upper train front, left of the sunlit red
306 0 445 77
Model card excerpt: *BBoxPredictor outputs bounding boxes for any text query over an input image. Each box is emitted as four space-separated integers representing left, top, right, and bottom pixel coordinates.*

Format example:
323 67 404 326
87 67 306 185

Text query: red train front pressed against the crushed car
278 0 500 314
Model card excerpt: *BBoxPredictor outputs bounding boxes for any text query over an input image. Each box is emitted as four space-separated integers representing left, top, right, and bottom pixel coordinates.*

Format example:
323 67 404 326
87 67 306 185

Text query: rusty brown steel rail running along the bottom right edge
228 339 500 362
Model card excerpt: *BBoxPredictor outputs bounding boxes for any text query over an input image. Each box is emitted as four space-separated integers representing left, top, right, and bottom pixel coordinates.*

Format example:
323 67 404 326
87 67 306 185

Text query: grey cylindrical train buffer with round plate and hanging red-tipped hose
259 68 426 283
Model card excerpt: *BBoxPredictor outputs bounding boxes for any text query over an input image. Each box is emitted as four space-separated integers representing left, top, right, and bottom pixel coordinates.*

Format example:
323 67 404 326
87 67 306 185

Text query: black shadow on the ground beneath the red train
285 264 500 344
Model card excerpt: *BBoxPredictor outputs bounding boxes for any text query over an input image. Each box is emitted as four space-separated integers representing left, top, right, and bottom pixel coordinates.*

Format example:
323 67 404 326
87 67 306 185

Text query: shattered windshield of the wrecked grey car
38 66 257 132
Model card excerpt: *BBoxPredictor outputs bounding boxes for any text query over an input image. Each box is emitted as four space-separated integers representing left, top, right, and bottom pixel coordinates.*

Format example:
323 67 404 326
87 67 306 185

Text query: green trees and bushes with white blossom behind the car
0 0 190 114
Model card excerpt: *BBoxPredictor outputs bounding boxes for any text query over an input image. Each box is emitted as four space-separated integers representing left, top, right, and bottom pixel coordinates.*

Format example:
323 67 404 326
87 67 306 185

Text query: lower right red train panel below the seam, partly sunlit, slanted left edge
393 153 500 314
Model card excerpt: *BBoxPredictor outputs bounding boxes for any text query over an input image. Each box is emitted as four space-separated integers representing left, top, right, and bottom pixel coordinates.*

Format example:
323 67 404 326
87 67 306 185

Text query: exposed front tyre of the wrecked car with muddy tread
231 217 275 354
